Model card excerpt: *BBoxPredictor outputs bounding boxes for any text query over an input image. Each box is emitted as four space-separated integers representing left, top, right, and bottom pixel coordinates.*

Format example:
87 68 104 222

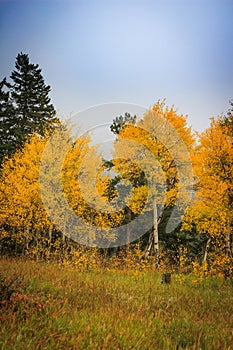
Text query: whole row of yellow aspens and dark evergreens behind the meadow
0 53 233 274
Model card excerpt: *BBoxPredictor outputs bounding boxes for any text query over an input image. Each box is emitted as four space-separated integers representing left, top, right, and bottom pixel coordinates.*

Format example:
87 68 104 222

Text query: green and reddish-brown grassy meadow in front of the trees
0 259 233 350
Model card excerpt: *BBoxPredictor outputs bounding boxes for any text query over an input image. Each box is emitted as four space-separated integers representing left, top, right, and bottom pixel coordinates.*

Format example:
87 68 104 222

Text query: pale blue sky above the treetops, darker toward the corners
0 0 233 131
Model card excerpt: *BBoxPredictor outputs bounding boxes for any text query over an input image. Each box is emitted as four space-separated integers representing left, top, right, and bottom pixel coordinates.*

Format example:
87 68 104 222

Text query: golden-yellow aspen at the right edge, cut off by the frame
183 116 233 261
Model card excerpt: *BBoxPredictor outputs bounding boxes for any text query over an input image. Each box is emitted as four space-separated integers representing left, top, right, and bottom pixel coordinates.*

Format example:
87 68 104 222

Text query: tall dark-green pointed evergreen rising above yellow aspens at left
11 53 58 141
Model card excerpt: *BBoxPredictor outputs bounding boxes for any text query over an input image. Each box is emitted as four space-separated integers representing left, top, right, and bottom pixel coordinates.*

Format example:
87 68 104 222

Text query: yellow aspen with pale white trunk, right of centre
113 101 194 267
